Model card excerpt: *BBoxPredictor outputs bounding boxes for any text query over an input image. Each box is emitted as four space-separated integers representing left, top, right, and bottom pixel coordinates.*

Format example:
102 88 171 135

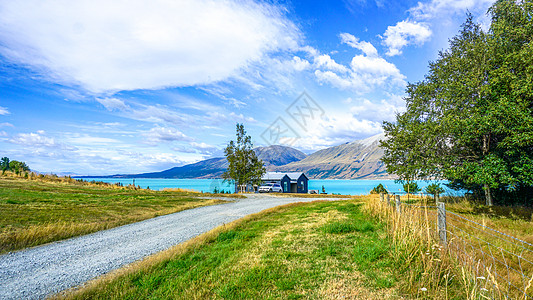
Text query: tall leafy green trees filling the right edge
382 0 533 205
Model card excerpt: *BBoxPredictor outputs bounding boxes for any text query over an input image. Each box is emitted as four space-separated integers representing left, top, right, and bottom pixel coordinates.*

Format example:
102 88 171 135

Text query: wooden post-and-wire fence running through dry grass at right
380 195 533 299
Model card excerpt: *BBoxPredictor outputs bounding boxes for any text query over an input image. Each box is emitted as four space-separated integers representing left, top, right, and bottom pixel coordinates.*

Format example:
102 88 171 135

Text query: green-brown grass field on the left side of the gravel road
0 177 224 253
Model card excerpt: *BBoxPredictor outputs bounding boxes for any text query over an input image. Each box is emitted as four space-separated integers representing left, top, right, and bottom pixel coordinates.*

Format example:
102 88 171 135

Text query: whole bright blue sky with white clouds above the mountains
0 0 493 175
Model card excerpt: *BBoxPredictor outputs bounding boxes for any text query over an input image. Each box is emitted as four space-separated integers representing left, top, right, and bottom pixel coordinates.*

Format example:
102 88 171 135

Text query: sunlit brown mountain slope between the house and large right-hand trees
276 134 392 179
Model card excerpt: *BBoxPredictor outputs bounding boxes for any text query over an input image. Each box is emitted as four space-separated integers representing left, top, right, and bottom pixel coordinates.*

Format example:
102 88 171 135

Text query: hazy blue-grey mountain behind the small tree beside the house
104 145 307 178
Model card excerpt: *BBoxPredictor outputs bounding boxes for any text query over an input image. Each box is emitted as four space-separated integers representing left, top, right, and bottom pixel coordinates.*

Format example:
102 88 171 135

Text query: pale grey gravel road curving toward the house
0 194 344 299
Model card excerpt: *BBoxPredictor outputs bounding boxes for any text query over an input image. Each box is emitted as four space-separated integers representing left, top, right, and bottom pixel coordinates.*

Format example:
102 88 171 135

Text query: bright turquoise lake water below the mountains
80 178 462 196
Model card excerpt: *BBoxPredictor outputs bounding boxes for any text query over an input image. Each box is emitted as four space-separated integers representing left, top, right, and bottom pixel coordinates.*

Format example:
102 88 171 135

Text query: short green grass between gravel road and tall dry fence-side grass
56 200 416 299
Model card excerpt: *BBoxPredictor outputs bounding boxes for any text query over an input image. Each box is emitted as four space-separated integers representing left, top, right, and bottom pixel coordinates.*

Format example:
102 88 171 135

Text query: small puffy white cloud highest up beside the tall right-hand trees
383 20 432 56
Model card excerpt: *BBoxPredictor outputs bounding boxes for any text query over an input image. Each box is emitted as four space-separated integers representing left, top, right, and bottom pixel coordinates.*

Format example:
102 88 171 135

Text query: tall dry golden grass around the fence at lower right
365 196 533 299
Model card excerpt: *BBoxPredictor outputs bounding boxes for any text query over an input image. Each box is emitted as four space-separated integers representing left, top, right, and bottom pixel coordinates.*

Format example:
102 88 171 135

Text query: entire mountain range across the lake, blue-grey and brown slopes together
92 134 392 179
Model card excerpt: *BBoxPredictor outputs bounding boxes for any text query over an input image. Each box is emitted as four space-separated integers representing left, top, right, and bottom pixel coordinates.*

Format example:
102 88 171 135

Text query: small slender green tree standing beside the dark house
222 124 266 192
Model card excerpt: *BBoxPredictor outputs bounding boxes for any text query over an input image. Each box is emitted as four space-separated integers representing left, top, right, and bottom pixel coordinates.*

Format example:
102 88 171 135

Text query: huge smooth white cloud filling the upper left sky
0 0 301 92
